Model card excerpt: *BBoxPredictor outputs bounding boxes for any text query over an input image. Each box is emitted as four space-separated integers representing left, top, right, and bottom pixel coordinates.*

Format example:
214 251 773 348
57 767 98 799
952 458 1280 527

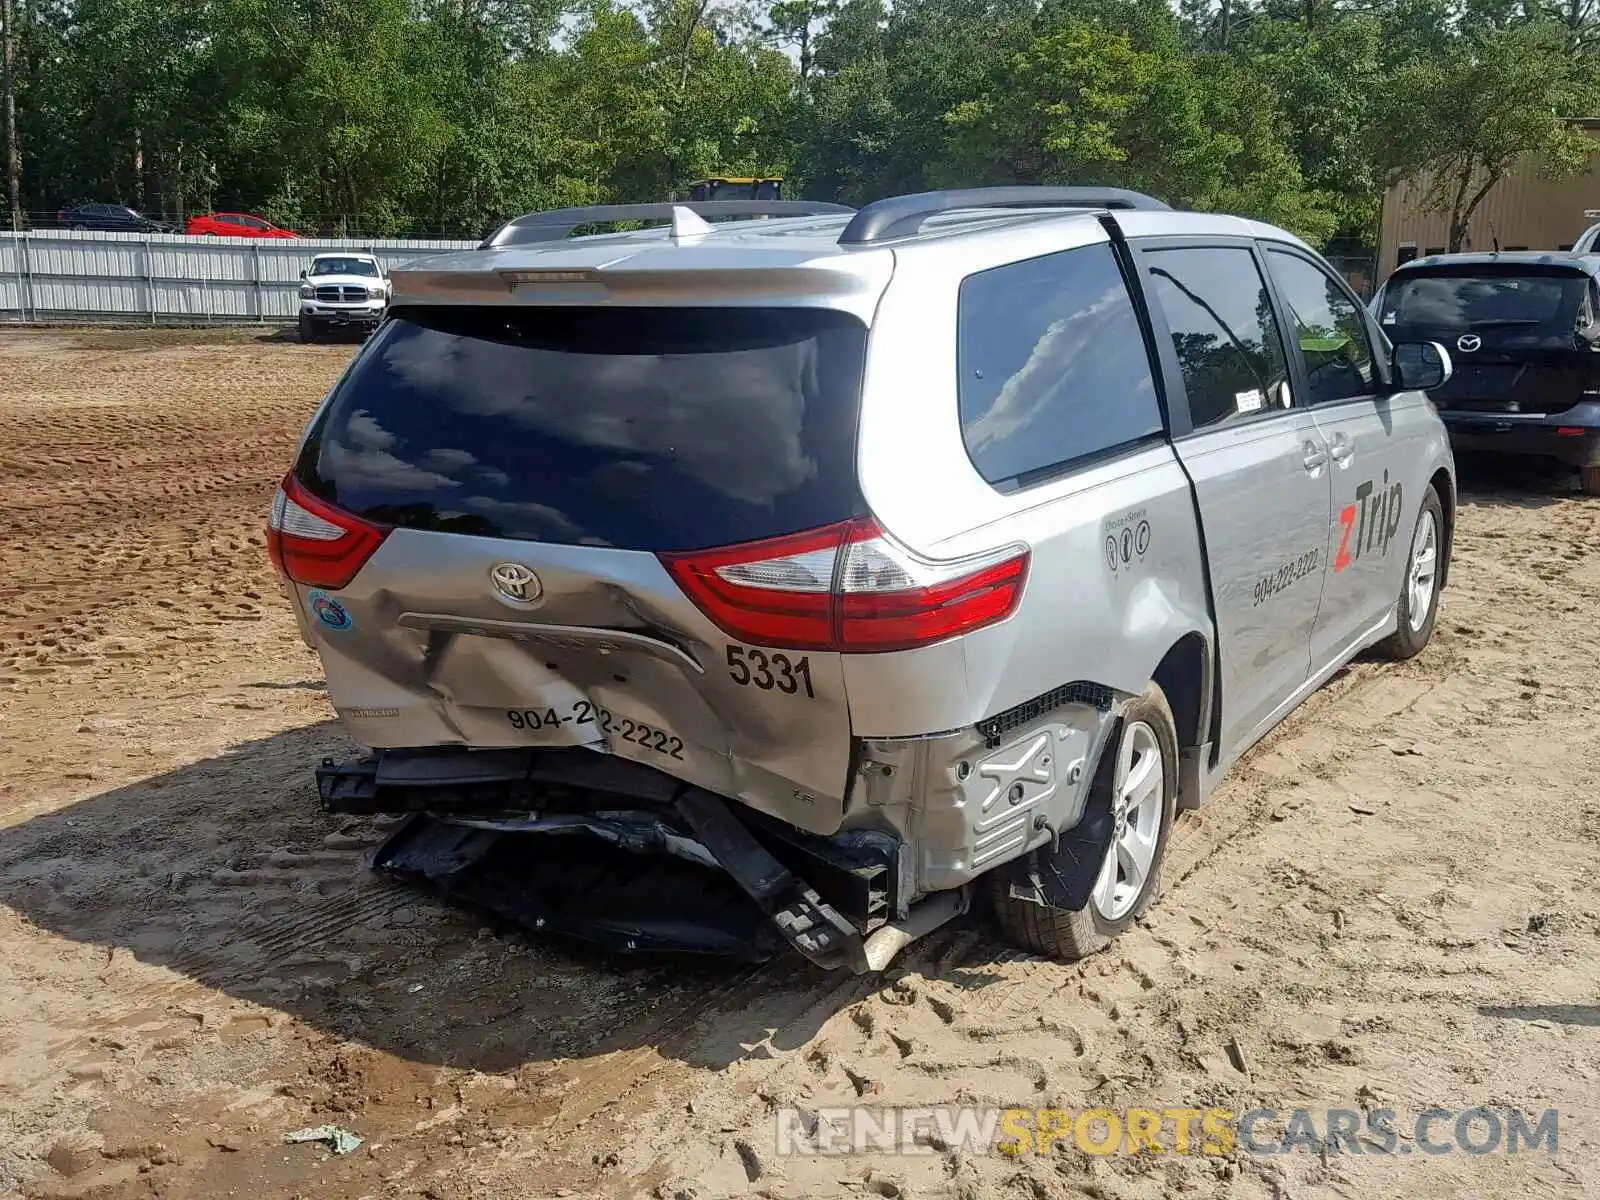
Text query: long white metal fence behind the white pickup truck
0 229 477 325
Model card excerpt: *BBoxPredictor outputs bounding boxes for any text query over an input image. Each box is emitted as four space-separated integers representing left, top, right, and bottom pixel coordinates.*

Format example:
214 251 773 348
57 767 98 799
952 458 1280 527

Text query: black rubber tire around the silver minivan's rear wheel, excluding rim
989 683 1178 962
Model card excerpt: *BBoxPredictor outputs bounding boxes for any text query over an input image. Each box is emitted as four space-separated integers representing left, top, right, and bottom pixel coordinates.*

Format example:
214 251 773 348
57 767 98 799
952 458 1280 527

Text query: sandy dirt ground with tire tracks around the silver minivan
0 331 1600 1200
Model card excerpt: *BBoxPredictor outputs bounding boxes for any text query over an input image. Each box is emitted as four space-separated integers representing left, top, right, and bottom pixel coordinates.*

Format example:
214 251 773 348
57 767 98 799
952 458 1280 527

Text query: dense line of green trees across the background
9 0 1600 254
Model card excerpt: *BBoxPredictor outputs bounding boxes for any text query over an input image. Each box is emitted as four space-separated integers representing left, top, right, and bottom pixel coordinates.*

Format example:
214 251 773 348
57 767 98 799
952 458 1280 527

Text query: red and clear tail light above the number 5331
661 518 1029 651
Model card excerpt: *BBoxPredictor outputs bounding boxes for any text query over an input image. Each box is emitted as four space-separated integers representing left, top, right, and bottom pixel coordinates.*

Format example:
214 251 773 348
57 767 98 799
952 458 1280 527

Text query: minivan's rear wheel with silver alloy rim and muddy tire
992 683 1178 960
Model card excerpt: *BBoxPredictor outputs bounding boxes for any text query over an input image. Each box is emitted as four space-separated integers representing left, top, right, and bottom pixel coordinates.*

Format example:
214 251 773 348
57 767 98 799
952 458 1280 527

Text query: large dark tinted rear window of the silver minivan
299 307 867 550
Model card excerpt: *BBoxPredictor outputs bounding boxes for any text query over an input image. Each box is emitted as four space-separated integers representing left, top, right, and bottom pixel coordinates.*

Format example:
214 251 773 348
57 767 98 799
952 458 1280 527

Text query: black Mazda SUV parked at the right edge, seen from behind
1373 251 1600 496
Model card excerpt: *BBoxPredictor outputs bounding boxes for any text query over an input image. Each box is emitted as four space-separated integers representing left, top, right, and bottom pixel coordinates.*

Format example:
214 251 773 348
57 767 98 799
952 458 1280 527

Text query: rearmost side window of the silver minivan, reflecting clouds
955 243 1162 486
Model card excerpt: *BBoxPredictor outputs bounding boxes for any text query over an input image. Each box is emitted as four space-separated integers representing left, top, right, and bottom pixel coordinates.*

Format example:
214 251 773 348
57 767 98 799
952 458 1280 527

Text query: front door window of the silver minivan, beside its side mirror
1267 250 1373 405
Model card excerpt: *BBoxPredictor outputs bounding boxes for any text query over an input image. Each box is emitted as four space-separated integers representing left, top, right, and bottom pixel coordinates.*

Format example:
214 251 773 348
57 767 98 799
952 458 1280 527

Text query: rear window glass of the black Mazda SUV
1379 272 1587 330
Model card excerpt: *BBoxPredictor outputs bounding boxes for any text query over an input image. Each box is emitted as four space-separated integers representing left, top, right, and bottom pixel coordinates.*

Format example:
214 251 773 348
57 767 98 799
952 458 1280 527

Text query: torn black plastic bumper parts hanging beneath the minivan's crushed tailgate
317 747 966 971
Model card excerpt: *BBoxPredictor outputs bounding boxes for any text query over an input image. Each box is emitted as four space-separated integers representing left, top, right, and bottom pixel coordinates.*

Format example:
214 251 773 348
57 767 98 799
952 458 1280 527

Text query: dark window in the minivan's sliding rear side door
1144 246 1290 429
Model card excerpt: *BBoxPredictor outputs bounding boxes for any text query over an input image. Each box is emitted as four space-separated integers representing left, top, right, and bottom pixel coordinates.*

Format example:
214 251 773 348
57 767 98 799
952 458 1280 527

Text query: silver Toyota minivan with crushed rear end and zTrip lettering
270 187 1456 970
